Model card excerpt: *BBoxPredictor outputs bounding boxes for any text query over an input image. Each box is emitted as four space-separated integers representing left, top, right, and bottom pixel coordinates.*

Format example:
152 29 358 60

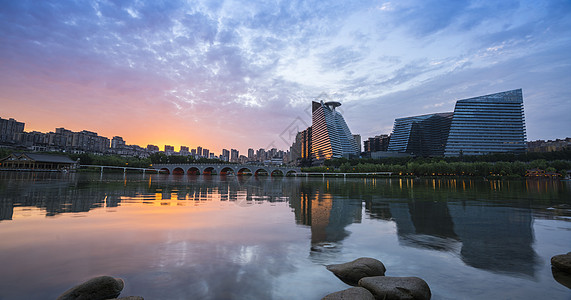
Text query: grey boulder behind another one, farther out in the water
326 257 386 286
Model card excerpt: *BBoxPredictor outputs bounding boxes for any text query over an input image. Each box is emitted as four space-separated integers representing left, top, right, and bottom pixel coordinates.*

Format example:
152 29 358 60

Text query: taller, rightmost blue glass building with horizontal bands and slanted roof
444 89 526 156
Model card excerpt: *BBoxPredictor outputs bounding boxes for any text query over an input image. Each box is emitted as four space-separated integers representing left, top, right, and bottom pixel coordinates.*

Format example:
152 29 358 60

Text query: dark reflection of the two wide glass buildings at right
366 180 539 277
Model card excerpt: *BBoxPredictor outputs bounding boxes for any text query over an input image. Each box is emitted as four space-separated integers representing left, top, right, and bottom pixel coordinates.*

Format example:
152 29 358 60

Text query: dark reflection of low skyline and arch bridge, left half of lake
0 172 290 221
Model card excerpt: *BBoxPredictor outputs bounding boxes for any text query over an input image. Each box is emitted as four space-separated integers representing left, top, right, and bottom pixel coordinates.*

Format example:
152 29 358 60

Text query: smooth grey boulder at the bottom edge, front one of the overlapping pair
359 276 431 300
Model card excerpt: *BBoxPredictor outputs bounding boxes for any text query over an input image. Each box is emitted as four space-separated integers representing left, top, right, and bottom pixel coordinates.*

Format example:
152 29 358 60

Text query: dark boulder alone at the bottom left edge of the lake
57 276 125 300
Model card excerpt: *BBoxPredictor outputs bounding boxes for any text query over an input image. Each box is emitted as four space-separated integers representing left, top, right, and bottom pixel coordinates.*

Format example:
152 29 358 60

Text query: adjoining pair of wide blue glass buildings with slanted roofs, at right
388 89 527 156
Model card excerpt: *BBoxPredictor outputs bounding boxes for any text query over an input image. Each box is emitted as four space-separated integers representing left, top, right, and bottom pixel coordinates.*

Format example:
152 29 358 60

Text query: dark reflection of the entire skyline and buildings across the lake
0 172 568 276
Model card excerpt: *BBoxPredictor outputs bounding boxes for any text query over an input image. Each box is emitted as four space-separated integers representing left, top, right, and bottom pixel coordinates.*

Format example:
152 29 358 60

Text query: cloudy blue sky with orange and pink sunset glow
0 0 571 154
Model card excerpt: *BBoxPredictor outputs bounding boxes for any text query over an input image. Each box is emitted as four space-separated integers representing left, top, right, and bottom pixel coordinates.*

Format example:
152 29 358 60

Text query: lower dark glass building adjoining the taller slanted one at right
388 112 453 156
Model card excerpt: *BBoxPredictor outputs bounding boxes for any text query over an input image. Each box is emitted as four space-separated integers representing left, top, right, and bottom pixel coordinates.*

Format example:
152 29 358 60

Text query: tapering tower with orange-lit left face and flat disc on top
311 101 359 163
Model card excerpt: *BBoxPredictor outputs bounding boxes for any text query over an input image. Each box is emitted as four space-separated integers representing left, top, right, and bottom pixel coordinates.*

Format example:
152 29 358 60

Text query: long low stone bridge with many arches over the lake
151 164 301 176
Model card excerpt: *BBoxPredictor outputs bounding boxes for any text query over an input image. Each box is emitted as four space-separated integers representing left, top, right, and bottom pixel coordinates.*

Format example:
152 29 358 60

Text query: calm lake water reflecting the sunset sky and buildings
0 172 571 300
